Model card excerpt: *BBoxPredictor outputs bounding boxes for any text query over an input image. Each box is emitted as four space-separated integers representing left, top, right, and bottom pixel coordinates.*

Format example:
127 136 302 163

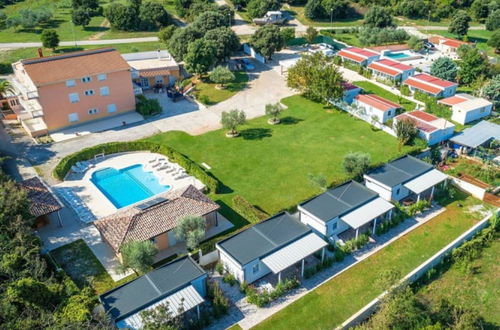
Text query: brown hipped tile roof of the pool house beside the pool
94 185 219 251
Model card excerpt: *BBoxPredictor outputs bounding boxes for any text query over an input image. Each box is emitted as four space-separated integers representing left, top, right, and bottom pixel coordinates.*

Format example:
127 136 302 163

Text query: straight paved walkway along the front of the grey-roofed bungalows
209 205 446 330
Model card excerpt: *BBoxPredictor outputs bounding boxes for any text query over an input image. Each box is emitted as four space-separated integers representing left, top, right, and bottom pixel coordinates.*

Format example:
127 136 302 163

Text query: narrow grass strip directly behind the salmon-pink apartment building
0 42 164 73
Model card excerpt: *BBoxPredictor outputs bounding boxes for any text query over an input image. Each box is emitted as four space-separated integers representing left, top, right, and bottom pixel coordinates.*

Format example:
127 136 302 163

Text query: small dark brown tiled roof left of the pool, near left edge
19 177 62 217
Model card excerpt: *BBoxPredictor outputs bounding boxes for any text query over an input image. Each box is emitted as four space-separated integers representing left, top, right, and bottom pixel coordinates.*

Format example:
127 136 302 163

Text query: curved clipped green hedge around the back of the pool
53 141 220 193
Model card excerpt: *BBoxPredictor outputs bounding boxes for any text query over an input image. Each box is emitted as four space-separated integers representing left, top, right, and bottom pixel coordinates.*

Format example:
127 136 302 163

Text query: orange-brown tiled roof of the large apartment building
21 48 130 86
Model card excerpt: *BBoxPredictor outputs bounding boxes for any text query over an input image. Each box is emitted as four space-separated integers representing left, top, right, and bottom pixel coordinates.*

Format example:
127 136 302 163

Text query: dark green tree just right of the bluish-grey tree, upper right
457 45 490 84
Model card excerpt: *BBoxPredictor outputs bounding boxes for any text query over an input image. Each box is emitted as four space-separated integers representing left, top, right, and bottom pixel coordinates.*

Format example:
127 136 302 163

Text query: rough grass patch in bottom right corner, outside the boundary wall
417 236 500 329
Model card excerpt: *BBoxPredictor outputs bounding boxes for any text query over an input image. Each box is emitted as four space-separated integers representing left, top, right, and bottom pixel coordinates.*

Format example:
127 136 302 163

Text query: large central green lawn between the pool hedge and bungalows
149 96 420 214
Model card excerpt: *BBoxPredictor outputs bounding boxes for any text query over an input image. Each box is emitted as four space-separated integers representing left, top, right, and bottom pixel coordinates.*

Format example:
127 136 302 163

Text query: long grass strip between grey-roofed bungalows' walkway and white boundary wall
255 193 481 330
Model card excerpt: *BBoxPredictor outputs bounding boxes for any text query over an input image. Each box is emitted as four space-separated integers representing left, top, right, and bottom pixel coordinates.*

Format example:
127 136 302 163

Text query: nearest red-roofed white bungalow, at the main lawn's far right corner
394 110 455 145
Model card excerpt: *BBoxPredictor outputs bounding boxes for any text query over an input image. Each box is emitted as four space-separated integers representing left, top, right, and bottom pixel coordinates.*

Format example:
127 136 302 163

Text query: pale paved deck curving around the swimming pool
54 152 204 219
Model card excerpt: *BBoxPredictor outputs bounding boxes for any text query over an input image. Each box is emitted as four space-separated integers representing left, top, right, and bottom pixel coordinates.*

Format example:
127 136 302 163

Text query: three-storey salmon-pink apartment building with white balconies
11 48 135 136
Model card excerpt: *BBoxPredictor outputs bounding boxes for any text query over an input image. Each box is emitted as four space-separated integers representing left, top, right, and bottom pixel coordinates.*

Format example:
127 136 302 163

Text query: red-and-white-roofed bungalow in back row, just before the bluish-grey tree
404 73 458 98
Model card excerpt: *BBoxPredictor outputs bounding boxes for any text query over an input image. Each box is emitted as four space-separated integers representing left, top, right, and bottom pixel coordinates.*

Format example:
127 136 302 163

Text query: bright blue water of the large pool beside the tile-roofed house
90 164 171 209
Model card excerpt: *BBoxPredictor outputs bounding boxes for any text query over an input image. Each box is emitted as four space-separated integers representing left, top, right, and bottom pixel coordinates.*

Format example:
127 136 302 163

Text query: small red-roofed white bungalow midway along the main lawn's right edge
353 94 401 123
